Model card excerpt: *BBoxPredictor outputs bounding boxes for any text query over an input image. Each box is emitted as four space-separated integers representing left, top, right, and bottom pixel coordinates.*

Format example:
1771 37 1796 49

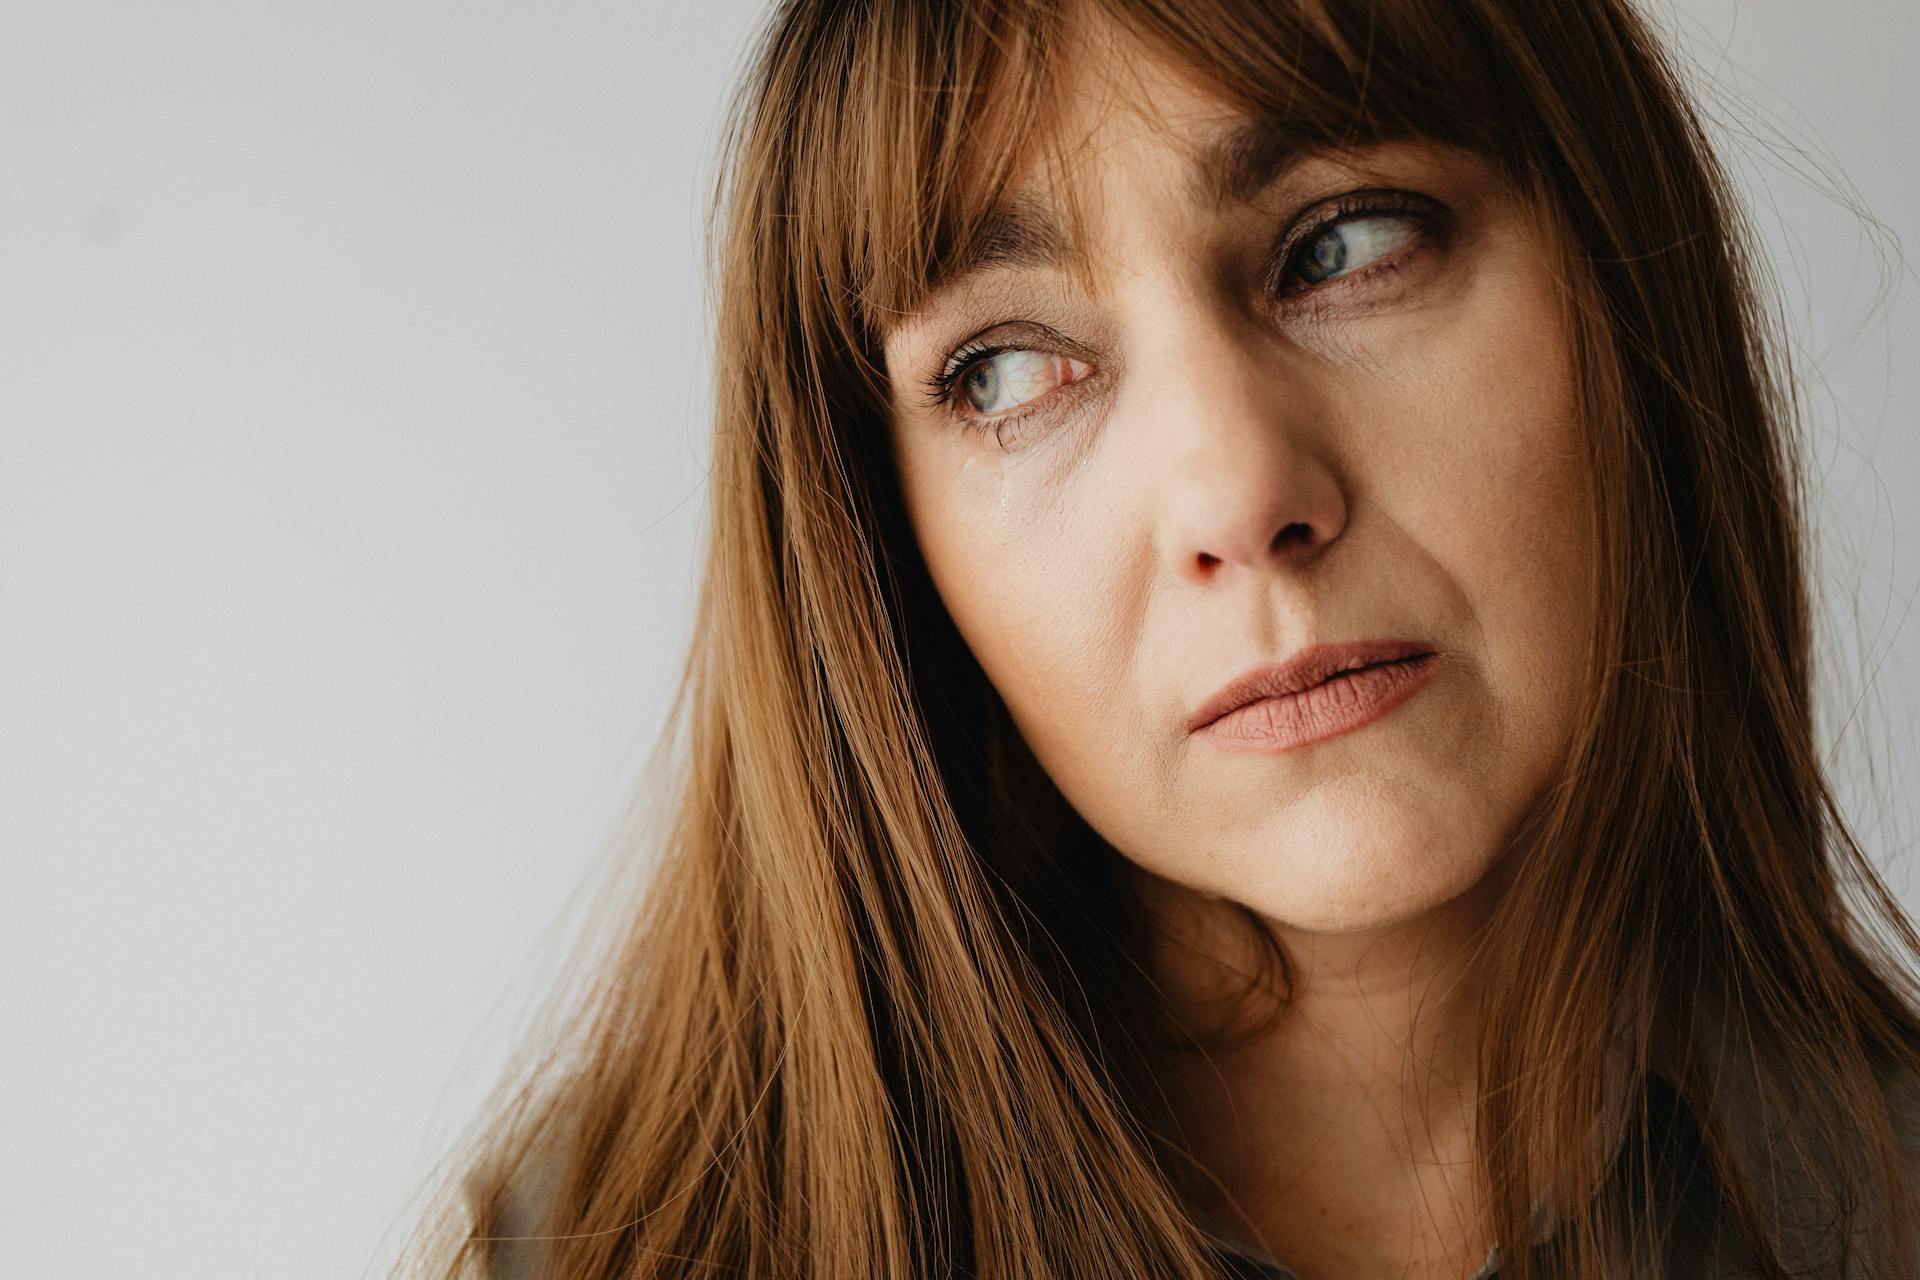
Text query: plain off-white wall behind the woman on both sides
0 0 1920 1280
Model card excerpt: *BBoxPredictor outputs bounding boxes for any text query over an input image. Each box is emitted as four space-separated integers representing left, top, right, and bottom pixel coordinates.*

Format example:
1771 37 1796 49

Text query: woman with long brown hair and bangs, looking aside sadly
393 0 1920 1280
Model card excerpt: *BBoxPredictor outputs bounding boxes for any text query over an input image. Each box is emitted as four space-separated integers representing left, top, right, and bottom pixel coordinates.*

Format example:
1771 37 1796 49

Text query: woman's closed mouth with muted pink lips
1187 641 1440 750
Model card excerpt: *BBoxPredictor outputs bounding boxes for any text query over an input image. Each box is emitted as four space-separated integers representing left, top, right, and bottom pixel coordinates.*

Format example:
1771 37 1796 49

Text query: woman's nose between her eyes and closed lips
1139 316 1348 583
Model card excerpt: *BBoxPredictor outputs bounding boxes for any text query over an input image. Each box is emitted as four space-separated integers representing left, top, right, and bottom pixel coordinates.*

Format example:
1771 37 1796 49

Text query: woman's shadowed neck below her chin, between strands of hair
1140 873 1490 1280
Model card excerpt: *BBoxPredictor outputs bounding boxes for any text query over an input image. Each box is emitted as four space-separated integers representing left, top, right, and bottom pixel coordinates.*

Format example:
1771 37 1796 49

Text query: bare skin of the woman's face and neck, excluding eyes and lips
885 29 1590 1280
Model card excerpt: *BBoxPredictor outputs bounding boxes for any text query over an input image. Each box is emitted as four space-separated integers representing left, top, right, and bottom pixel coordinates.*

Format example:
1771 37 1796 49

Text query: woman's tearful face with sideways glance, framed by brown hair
885 47 1590 933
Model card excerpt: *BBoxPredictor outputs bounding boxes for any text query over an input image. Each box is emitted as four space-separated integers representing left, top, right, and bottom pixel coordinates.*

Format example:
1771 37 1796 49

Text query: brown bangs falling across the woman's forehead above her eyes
768 0 1526 388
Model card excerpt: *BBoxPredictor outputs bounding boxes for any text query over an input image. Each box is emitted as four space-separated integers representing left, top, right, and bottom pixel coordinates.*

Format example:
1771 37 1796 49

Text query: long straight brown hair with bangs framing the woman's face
403 0 1920 1280
